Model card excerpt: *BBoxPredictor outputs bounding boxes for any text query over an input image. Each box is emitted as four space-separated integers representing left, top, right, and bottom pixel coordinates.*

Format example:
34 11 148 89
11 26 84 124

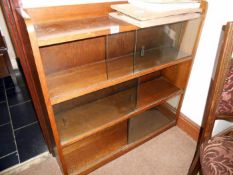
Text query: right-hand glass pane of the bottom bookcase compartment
128 96 180 143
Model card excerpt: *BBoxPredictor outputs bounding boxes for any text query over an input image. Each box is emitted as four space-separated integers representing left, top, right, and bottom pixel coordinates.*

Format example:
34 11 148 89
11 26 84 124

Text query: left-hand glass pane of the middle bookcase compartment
54 80 137 144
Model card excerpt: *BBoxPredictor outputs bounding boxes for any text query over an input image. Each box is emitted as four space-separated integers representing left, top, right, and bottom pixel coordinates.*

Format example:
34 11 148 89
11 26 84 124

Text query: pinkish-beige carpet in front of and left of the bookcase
0 126 196 175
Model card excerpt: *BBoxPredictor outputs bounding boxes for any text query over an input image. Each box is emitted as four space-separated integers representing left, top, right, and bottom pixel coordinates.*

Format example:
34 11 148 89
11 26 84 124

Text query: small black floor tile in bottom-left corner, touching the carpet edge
0 153 19 171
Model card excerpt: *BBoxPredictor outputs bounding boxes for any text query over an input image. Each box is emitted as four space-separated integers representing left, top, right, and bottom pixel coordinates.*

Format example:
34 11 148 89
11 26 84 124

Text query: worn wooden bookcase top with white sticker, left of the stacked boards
35 16 138 47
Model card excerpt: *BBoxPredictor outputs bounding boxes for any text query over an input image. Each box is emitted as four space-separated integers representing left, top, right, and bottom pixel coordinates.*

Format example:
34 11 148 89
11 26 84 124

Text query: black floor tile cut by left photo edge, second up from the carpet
0 124 16 157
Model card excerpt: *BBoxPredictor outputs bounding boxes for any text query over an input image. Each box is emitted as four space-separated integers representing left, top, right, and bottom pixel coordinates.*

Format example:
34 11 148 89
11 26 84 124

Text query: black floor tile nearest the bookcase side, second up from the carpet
10 101 37 129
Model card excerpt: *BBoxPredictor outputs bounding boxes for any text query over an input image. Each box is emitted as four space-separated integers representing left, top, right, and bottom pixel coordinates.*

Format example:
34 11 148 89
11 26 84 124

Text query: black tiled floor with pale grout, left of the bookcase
0 77 47 171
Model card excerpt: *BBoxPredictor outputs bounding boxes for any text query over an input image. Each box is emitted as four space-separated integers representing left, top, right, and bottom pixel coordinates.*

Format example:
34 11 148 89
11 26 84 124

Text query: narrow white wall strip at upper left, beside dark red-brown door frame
0 8 17 69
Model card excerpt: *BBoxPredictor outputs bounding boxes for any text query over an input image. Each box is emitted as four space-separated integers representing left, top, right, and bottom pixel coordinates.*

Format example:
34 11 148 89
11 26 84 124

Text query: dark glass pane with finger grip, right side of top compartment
135 22 191 73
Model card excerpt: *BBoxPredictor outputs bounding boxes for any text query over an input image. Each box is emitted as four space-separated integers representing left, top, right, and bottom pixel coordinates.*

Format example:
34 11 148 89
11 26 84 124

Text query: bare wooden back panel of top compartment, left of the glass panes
40 37 105 75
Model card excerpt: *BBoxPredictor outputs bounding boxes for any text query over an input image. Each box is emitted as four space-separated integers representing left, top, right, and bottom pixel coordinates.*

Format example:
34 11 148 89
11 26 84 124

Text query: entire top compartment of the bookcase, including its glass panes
45 19 200 103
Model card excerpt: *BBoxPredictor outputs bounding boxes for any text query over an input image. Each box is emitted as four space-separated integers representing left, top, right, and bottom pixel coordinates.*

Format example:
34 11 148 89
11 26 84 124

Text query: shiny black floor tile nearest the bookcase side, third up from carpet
6 86 30 106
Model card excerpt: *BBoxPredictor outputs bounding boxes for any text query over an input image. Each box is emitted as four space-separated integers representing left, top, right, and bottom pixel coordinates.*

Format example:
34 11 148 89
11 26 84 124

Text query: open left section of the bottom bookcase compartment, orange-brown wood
63 122 127 174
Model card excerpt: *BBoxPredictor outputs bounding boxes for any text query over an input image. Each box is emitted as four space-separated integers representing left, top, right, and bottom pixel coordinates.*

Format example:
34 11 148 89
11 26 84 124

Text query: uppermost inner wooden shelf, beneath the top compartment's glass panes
46 48 191 105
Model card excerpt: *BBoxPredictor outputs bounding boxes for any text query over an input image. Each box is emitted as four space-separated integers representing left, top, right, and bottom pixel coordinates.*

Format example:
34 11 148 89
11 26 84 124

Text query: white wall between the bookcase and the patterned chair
181 0 233 130
